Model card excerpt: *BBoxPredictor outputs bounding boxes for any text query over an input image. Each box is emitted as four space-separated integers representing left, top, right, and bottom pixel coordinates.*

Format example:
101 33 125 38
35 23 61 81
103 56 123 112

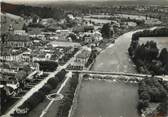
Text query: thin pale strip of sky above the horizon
0 0 168 4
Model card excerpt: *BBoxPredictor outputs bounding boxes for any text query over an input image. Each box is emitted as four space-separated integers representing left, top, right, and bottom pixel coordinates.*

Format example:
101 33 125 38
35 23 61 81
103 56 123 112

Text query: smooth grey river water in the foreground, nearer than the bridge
74 80 138 117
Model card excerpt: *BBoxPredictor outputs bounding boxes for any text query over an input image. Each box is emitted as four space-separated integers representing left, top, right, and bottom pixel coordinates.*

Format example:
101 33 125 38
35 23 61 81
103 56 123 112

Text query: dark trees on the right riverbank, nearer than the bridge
137 78 168 114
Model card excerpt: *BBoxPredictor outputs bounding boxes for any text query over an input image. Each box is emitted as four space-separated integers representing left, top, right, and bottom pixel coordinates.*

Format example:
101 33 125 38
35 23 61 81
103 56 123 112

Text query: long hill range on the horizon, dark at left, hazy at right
1 0 168 19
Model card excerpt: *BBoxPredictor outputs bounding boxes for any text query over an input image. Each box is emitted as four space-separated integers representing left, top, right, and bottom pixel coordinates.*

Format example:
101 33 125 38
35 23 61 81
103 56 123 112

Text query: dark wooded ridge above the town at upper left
1 2 65 20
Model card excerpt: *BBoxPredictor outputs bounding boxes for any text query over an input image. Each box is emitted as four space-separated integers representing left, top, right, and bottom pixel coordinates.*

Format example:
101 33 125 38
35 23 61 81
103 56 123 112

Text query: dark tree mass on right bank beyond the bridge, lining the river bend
128 28 168 75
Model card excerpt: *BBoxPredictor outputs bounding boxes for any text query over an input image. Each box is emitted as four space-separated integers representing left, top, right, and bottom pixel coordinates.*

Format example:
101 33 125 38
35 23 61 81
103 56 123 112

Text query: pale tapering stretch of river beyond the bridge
92 32 136 73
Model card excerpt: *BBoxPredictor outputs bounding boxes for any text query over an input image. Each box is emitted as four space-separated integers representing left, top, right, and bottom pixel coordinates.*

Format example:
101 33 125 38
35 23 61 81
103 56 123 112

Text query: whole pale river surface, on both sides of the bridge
74 32 138 117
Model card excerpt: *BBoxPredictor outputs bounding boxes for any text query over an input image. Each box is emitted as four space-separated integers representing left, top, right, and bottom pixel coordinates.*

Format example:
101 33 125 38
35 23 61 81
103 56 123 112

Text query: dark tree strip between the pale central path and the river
57 73 79 117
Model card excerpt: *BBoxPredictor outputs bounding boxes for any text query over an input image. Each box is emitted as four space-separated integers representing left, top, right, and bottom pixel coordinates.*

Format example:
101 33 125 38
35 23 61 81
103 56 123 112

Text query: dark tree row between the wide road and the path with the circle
13 69 66 117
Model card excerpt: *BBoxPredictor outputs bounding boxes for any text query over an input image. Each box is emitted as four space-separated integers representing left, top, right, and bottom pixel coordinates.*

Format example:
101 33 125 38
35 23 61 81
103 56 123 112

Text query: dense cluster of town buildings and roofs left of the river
0 12 103 109
